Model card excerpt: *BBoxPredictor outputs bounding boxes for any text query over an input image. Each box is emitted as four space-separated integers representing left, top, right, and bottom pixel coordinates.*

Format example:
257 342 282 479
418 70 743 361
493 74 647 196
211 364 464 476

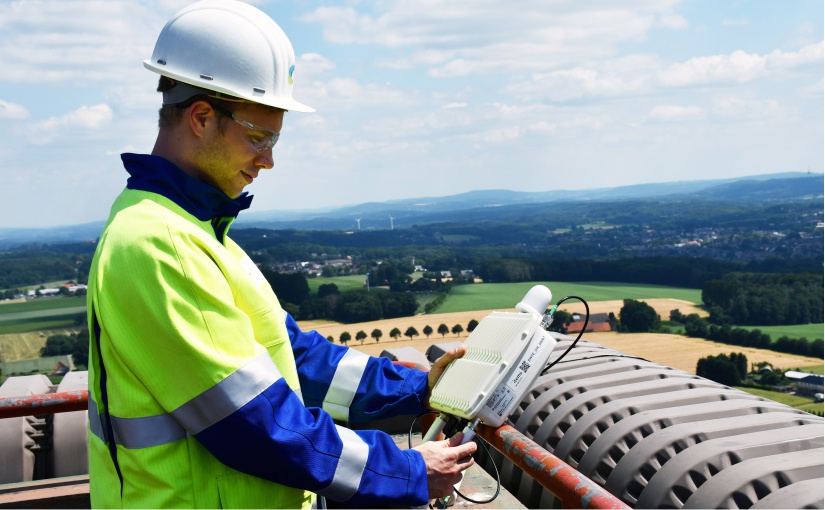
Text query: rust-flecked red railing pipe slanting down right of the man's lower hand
478 425 630 508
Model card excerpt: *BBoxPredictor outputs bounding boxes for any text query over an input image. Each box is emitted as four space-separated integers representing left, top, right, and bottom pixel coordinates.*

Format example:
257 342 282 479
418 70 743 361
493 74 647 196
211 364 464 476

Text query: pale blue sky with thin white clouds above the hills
0 0 825 228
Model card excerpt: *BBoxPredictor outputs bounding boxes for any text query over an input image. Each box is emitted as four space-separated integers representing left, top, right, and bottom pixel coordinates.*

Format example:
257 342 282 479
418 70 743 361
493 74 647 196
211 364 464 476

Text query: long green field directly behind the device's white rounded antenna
435 282 702 313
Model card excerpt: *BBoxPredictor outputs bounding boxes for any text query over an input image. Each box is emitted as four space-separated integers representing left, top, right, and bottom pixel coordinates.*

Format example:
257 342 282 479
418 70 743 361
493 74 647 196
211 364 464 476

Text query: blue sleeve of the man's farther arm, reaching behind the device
286 315 427 424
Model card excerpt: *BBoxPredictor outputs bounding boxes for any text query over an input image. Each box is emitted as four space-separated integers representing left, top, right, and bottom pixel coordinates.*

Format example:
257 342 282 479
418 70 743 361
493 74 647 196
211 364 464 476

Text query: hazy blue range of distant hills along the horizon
0 172 824 250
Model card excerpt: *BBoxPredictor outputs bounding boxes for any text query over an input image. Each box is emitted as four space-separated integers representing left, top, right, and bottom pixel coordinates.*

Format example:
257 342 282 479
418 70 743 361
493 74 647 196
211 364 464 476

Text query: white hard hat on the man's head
143 0 315 112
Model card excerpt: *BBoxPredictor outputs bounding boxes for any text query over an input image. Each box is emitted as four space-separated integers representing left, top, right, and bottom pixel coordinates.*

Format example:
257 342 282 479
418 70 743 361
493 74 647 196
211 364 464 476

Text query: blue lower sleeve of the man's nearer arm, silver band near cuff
193 355 427 508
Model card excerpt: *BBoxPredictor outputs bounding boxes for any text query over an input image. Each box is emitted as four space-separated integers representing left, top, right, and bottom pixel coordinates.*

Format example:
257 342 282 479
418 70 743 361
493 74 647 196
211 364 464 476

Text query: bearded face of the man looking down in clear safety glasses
193 104 284 198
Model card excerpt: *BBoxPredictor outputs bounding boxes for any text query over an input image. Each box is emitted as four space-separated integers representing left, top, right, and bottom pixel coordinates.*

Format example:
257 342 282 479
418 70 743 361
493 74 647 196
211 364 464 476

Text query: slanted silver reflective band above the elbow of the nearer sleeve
172 352 281 435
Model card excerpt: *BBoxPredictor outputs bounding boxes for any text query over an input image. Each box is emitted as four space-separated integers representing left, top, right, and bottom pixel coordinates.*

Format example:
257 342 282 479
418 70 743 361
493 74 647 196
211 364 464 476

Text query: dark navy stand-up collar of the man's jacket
120 153 252 221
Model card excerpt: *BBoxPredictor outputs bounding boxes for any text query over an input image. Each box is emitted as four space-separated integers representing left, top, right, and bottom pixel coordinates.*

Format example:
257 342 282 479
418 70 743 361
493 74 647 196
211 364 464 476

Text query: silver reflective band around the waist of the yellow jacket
89 399 186 449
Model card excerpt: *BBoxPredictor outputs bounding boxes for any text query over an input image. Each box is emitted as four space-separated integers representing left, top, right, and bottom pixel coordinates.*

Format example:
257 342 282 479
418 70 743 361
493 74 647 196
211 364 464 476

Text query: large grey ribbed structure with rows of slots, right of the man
478 335 825 508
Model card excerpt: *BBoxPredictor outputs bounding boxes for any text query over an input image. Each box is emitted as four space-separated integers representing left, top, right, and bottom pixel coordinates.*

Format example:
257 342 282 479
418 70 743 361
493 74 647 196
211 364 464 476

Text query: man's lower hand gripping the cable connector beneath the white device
413 432 477 499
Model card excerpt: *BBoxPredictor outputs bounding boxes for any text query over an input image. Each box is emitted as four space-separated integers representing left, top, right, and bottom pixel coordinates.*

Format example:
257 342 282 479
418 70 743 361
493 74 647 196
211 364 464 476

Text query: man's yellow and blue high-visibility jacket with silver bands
88 154 427 508
